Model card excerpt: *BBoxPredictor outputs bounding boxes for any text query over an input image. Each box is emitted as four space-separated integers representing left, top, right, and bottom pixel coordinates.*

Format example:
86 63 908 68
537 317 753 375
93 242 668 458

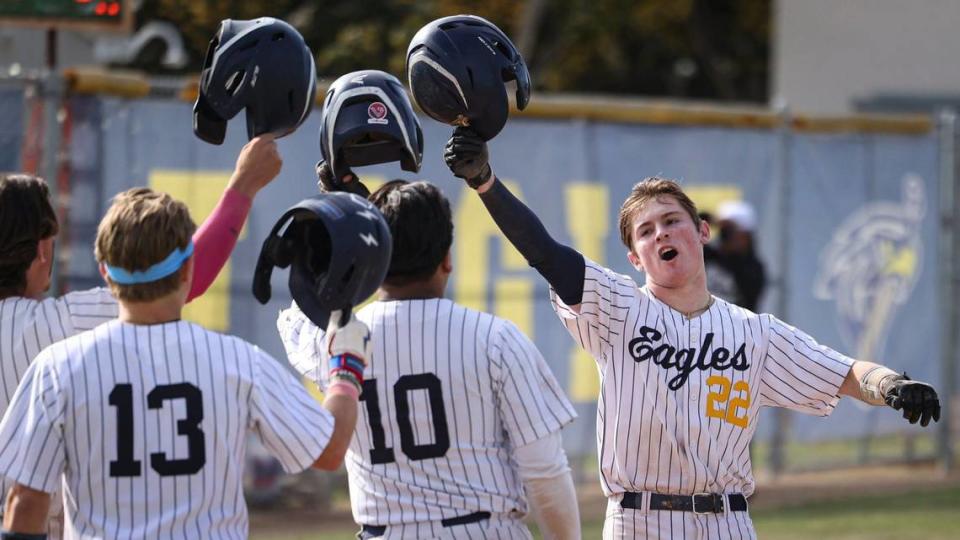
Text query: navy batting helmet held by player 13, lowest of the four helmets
253 192 393 328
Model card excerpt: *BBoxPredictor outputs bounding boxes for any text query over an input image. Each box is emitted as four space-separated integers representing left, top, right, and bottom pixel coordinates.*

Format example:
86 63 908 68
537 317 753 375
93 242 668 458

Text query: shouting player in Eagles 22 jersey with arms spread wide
444 128 940 539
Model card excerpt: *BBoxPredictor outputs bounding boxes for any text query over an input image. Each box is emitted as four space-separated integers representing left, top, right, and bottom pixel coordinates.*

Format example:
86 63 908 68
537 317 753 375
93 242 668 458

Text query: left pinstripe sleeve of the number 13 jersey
0 348 66 493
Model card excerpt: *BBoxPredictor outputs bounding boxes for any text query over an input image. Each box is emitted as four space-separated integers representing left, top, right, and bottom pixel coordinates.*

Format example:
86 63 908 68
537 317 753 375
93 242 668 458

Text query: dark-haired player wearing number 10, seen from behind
277 175 580 539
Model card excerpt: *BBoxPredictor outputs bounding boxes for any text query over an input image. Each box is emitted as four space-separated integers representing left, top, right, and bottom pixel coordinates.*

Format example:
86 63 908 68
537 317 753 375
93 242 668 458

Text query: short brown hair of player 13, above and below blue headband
95 188 197 302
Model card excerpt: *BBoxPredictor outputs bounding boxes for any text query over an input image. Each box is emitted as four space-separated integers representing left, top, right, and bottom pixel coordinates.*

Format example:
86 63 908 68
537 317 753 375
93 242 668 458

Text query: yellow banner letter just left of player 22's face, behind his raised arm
565 182 610 401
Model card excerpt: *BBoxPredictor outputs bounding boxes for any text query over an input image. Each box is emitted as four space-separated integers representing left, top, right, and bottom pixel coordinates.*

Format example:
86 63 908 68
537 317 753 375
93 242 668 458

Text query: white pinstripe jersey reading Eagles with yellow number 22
551 260 853 537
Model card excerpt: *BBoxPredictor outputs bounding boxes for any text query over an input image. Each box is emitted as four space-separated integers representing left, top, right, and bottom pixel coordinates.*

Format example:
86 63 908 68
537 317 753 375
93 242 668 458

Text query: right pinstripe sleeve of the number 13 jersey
250 349 334 473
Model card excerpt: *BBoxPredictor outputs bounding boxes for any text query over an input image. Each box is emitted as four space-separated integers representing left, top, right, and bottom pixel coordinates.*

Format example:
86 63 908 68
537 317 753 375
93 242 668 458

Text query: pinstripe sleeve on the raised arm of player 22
550 258 637 362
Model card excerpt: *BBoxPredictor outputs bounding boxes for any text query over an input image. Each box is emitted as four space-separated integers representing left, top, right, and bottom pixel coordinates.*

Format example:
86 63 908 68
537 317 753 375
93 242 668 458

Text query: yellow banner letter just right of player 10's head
453 179 533 339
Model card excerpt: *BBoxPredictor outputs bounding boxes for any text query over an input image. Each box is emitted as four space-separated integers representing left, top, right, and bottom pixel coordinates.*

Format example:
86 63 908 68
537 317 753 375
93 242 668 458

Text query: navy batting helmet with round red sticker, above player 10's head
320 69 423 178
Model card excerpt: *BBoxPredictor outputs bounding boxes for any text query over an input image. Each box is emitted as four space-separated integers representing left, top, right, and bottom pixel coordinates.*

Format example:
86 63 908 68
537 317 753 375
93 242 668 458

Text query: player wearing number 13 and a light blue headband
0 188 368 538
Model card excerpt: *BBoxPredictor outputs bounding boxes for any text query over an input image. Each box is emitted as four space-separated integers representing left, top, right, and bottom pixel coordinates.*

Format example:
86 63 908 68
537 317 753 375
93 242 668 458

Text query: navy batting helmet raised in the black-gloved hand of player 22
407 15 530 140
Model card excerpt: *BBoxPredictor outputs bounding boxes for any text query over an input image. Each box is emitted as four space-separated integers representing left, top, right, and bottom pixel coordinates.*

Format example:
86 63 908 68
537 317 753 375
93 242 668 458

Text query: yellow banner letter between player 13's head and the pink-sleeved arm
150 170 240 332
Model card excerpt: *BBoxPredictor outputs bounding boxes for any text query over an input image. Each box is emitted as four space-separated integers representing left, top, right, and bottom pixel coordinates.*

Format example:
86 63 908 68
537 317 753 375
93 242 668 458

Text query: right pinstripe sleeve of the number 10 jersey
492 319 577 447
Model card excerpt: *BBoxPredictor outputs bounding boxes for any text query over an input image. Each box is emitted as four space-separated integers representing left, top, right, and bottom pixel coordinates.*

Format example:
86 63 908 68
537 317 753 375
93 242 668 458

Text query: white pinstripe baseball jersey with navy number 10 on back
277 298 576 538
